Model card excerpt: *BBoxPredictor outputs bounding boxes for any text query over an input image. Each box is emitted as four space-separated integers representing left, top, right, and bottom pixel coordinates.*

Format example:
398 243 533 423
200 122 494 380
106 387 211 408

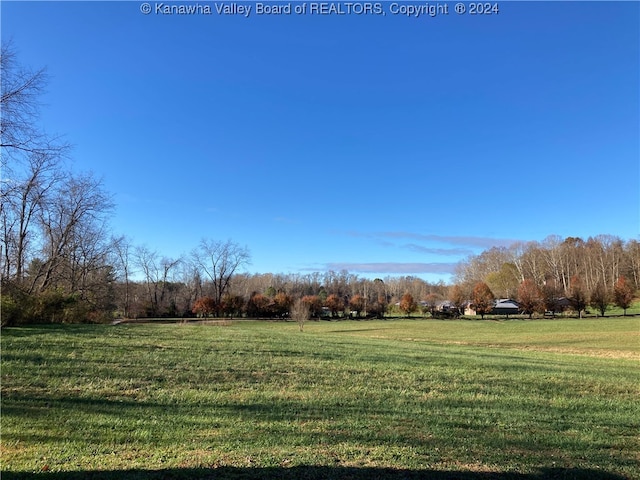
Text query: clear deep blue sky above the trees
1 1 640 281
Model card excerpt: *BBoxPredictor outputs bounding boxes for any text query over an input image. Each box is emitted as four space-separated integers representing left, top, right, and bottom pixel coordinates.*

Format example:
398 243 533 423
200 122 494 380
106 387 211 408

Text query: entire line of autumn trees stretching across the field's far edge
0 44 640 325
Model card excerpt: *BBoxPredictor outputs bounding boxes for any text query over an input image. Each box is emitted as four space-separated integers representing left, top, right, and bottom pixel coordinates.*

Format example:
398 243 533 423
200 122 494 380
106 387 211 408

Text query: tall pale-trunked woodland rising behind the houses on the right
455 235 640 316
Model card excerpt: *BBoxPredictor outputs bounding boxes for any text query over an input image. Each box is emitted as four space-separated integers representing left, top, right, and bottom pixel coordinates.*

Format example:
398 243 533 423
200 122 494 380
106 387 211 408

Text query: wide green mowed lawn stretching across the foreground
1 317 640 480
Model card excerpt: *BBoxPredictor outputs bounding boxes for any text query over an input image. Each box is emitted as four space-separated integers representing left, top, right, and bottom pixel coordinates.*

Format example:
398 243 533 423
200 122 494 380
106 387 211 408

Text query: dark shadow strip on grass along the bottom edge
2 466 627 480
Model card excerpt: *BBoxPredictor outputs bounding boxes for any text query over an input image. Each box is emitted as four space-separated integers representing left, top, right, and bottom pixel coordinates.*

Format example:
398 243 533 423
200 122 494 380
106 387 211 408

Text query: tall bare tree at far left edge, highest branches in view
0 43 68 288
